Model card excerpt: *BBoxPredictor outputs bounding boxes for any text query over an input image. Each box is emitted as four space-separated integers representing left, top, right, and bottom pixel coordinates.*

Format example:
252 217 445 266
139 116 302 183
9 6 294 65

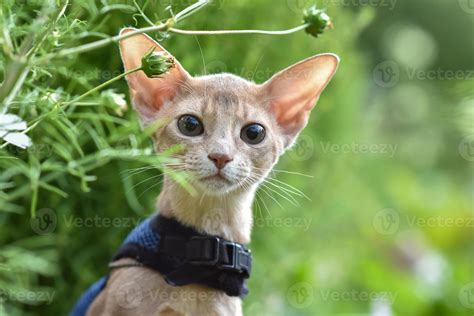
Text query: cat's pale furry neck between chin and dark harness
157 177 256 244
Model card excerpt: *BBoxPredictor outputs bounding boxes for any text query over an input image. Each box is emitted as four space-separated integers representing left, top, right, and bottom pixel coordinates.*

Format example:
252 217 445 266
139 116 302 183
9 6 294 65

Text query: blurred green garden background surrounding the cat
0 0 474 316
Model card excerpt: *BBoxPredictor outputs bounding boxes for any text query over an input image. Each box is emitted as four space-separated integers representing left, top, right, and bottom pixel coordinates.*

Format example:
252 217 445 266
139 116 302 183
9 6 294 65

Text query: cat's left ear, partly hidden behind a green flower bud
120 28 190 125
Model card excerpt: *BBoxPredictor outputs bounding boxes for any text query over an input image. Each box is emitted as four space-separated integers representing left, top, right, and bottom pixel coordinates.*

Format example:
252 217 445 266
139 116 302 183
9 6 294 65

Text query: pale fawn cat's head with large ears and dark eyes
120 29 339 195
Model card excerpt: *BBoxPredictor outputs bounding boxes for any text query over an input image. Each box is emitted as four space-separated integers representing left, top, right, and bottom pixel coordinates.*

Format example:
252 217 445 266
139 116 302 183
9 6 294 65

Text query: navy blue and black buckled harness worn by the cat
70 215 252 316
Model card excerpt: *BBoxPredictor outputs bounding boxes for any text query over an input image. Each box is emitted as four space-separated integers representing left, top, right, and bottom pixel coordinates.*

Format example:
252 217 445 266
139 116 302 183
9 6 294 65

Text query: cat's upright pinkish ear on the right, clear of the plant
262 54 339 146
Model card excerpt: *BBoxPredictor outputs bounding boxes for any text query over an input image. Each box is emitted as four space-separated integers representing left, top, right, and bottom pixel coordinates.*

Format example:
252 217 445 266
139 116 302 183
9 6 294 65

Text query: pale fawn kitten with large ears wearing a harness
84 28 339 316
